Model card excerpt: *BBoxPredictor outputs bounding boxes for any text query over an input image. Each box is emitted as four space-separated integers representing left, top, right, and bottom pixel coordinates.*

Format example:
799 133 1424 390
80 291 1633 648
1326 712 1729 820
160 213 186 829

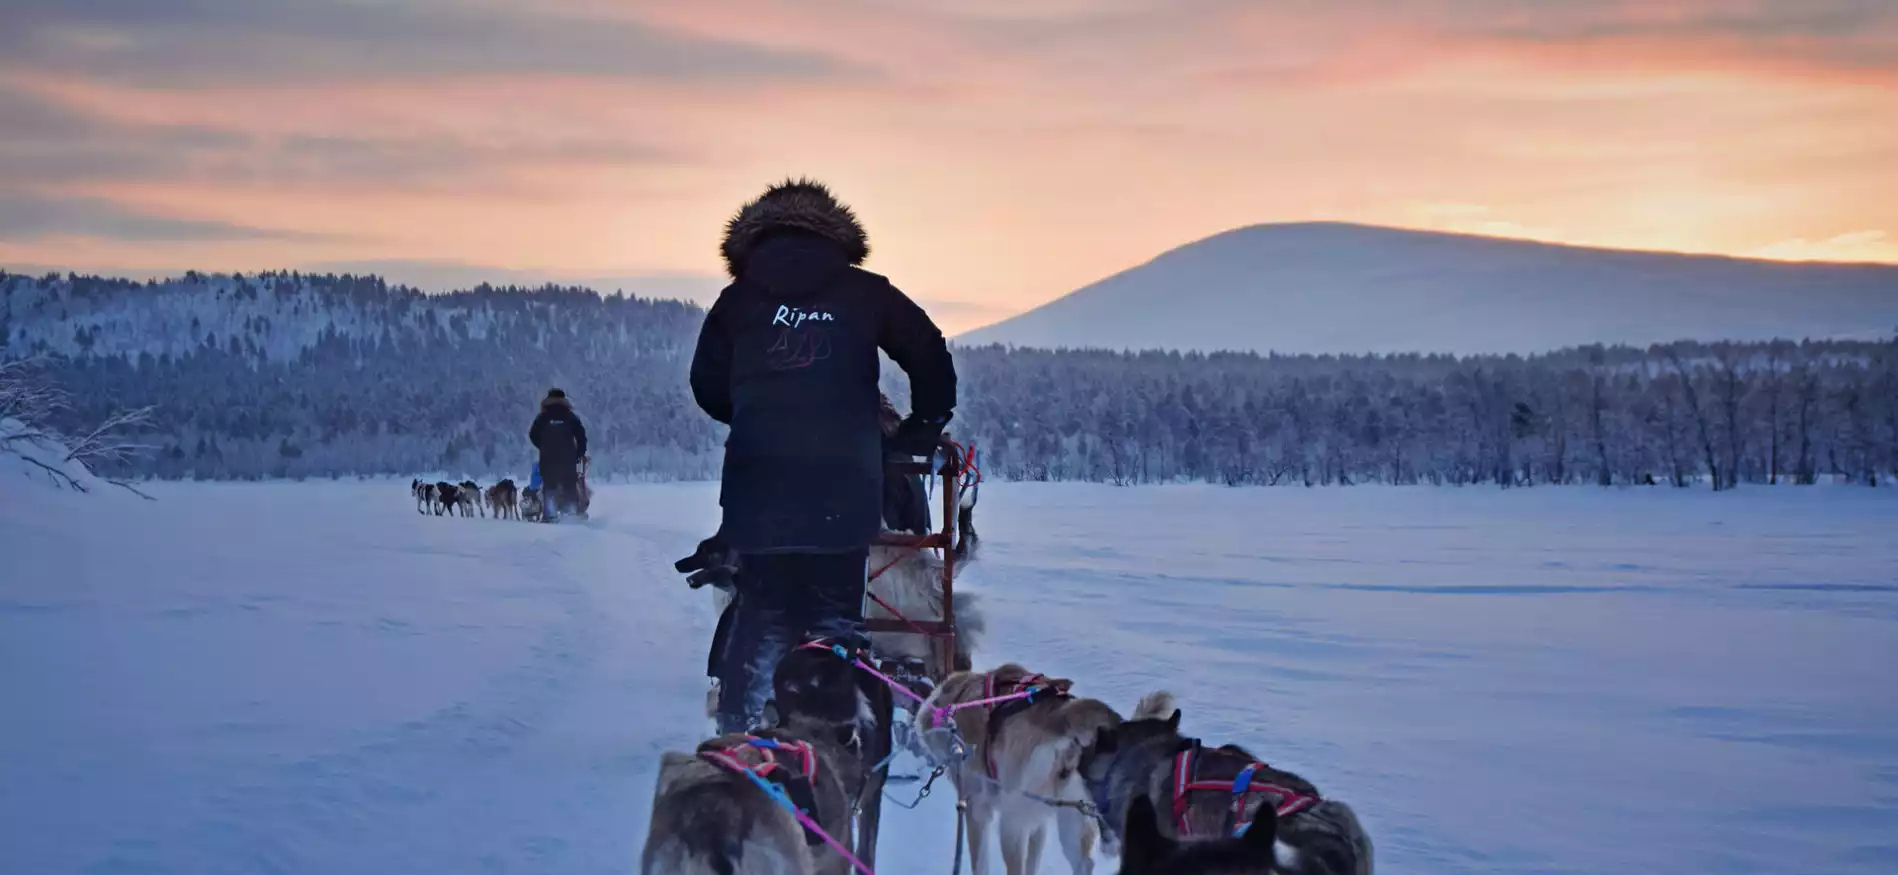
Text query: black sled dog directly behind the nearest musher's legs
765 642 894 869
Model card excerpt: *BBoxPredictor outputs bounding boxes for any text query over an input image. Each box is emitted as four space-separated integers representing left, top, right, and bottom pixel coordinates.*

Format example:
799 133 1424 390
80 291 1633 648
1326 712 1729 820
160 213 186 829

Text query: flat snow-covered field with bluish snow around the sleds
0 478 1898 875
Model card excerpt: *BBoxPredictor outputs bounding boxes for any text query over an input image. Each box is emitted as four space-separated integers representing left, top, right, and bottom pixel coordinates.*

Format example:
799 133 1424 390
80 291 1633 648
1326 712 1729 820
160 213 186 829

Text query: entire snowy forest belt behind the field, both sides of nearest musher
11 273 1898 488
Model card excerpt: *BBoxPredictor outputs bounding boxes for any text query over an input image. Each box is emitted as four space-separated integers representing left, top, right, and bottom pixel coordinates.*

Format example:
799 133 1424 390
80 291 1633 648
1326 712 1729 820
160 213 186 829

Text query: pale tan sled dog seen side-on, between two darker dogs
919 662 1120 875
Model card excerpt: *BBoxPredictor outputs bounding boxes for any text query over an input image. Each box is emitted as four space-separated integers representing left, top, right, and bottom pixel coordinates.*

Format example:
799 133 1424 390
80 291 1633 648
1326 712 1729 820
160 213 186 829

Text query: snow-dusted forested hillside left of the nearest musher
0 273 721 480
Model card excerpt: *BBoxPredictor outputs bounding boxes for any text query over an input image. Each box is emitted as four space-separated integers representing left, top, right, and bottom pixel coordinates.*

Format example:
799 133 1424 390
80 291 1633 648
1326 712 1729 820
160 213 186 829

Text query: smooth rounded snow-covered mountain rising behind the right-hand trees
957 222 1898 355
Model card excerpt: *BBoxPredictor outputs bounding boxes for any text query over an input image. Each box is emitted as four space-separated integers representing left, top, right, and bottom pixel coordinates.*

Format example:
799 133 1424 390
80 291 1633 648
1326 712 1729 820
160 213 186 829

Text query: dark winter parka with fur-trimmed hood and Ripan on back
691 182 957 554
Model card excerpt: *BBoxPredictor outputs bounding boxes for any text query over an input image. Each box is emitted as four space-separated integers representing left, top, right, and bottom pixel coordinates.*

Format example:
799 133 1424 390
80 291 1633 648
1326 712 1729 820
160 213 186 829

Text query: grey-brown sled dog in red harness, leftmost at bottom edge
640 729 850 875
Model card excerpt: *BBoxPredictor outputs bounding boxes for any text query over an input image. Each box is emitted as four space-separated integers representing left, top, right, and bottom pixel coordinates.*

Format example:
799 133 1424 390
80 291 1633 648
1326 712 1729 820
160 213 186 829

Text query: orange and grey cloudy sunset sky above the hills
0 0 1898 330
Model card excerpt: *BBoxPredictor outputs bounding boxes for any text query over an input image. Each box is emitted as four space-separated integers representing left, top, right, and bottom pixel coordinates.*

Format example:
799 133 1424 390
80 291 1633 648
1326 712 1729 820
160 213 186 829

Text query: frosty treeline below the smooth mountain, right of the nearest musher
941 340 1898 490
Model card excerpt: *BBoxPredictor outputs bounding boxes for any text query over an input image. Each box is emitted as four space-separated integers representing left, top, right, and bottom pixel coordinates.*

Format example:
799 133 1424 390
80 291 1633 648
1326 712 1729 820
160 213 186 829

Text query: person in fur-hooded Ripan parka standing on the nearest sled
691 180 957 733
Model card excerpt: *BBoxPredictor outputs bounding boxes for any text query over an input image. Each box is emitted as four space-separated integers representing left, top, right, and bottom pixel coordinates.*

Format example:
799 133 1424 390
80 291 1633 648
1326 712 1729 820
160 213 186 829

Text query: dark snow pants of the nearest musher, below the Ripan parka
712 549 869 733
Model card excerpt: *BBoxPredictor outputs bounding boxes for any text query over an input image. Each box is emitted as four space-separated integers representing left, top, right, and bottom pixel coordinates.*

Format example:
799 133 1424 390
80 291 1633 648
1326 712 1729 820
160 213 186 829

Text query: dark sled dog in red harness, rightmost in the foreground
1080 693 1372 875
